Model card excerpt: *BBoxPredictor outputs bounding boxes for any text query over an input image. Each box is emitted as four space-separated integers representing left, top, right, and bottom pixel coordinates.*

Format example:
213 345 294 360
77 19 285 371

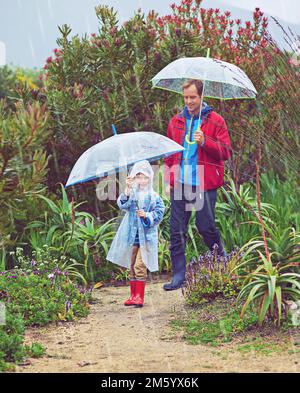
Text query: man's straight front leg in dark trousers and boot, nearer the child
164 184 191 290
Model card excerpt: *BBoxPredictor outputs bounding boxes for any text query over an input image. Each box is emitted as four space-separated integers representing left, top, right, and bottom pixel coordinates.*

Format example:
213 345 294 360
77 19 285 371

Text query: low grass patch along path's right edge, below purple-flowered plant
171 300 297 355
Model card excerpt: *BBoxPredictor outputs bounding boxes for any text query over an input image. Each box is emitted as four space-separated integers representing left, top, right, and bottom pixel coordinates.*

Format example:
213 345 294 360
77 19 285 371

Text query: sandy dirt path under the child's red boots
16 283 300 373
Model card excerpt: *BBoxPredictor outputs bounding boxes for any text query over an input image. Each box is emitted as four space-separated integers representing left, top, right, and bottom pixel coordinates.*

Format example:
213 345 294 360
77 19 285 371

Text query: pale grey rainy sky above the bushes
0 0 300 68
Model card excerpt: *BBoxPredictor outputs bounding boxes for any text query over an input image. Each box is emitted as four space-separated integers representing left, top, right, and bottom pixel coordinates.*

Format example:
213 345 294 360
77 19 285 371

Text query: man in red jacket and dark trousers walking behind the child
164 80 231 290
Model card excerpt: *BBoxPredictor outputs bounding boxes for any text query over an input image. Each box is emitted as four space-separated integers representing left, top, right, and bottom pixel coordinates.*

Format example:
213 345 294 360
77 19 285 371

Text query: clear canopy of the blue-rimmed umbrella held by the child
65 131 184 187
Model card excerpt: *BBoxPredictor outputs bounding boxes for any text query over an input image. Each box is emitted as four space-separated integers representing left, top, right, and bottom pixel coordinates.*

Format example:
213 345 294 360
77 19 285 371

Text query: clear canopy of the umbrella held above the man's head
152 57 257 100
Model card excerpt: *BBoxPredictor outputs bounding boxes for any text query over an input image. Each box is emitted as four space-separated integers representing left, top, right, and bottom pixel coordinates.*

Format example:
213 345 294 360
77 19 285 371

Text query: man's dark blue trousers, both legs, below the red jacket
170 186 226 283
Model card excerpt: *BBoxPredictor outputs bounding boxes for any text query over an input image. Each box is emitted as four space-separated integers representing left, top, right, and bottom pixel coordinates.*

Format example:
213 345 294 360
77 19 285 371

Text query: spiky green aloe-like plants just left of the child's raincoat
19 185 115 282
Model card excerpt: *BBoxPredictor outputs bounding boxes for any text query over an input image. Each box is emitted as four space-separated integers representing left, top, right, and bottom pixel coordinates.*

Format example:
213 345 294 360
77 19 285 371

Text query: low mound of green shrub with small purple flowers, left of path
0 269 90 326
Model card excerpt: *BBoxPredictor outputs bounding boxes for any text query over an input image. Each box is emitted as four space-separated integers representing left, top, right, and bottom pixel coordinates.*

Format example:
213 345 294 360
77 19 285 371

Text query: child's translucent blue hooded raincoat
106 160 165 272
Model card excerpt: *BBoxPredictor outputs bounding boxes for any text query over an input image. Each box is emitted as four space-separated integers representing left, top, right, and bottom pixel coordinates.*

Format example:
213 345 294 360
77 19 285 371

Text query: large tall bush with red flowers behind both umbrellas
40 0 286 211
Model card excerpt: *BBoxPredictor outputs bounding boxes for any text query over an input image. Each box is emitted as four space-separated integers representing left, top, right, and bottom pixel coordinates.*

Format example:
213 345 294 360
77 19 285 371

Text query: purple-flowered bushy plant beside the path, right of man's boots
183 244 241 305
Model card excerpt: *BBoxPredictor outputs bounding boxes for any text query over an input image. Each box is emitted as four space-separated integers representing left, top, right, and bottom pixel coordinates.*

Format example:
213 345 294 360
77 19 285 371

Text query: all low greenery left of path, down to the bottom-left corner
0 265 91 371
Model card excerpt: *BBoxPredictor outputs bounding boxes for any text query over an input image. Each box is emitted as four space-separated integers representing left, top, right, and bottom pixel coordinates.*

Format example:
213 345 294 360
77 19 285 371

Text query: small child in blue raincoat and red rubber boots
107 160 165 307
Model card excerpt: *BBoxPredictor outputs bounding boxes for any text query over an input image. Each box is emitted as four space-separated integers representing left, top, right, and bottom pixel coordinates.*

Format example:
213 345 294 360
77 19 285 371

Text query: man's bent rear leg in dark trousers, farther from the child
196 190 226 256
